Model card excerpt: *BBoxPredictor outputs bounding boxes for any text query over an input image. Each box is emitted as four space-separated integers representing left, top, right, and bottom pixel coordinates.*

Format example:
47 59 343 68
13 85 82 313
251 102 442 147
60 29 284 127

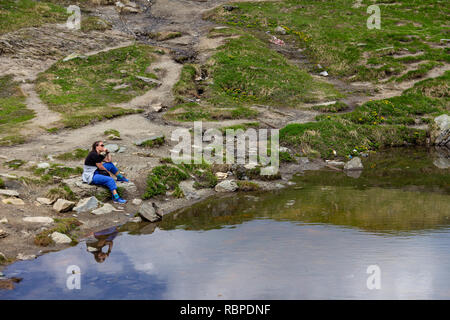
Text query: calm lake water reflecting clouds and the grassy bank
0 150 450 299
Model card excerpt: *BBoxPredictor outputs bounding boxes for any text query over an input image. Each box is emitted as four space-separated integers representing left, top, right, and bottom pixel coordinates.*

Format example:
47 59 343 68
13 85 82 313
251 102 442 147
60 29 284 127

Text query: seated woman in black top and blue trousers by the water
83 141 129 203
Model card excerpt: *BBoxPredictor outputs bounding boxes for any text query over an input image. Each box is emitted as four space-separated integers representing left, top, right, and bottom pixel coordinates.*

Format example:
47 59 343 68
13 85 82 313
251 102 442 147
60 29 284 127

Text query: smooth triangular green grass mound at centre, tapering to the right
207 34 342 107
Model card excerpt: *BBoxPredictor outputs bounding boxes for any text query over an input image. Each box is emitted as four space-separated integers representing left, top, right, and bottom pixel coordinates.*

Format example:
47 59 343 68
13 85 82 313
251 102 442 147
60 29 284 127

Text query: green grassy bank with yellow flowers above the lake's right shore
280 71 450 158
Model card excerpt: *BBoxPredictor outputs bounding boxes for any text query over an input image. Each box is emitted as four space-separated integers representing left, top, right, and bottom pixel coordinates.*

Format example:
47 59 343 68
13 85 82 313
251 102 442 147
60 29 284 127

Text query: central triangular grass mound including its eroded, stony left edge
166 28 342 121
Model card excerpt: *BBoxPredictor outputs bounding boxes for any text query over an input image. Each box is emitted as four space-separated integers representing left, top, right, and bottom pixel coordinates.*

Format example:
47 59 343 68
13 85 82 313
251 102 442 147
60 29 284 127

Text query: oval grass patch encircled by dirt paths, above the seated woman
36 45 157 128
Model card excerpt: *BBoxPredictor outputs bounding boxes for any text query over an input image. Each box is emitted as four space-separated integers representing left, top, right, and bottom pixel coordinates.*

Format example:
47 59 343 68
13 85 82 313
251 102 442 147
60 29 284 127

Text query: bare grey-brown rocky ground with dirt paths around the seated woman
0 0 450 280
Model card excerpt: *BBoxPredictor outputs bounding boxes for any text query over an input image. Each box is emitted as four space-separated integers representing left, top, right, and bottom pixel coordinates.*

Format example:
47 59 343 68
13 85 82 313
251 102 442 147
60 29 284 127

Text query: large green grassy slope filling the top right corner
212 0 450 81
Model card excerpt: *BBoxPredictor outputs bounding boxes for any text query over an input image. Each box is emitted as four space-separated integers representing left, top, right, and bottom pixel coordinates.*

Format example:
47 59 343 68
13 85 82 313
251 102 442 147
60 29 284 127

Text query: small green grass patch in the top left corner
0 0 68 35
